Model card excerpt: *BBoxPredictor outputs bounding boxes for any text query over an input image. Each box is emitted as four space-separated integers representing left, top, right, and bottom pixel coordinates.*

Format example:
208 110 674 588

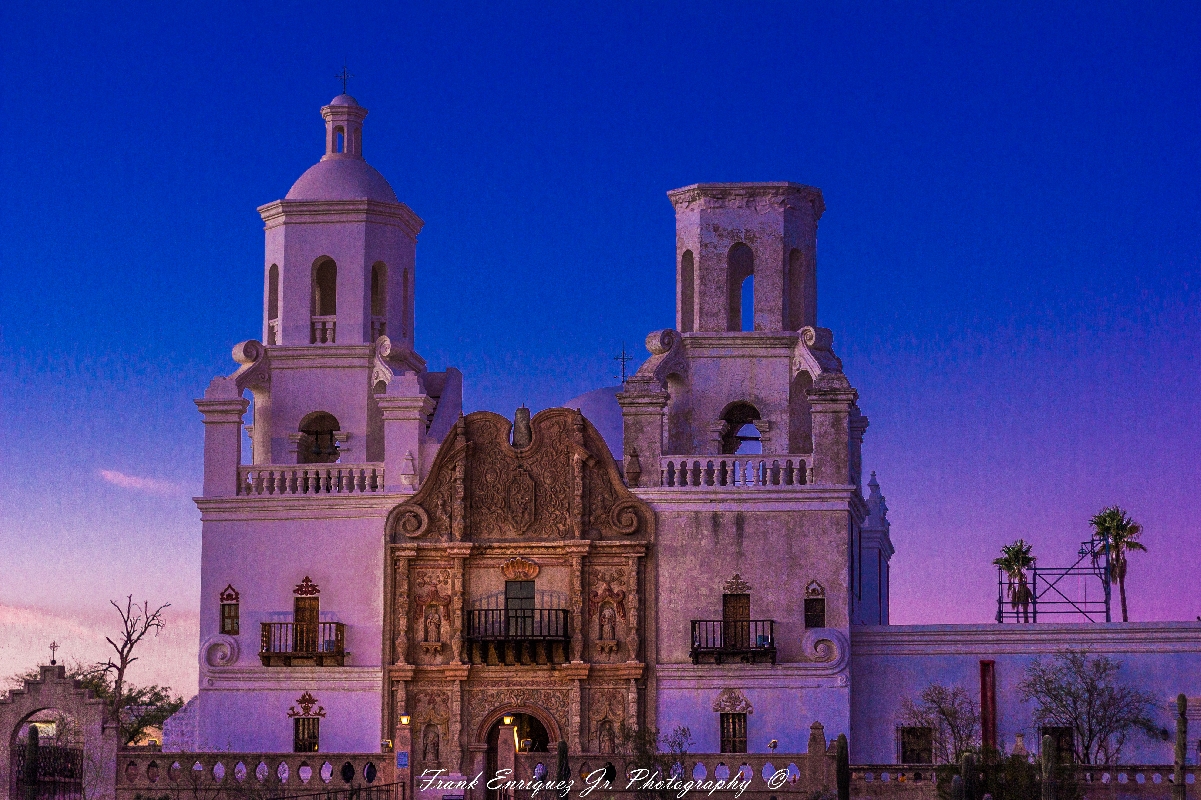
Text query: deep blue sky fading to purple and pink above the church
0 2 1201 682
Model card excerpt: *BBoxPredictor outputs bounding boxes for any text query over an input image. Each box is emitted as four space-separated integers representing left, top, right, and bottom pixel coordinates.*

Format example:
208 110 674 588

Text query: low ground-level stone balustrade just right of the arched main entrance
514 752 835 798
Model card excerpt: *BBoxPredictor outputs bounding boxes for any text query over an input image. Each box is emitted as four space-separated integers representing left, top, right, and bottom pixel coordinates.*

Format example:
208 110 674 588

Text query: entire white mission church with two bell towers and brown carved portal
180 94 1201 776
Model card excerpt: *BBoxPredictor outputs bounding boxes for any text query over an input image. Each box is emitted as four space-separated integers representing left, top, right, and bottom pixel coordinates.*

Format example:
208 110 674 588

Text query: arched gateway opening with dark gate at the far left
8 709 84 800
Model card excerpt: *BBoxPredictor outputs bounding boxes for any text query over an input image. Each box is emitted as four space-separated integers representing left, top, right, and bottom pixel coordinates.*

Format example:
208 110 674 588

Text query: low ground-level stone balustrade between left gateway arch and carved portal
116 750 395 800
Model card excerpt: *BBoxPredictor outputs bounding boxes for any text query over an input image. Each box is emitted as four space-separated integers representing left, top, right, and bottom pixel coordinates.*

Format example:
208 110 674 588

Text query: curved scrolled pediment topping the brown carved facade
388 408 655 542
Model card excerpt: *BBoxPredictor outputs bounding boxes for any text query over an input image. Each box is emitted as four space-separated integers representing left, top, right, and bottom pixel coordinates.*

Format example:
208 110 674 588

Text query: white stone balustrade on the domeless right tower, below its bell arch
659 453 813 489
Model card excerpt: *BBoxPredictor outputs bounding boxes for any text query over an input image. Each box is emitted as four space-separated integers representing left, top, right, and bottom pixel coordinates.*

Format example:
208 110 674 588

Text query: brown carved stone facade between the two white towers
386 408 655 772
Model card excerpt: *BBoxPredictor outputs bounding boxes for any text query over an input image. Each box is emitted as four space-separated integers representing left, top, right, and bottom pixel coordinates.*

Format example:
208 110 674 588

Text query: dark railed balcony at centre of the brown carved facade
464 608 572 667
